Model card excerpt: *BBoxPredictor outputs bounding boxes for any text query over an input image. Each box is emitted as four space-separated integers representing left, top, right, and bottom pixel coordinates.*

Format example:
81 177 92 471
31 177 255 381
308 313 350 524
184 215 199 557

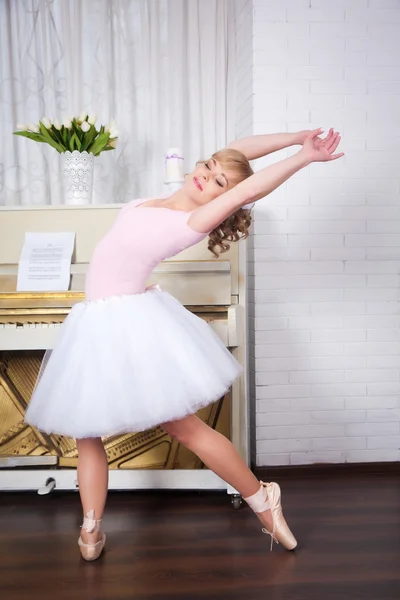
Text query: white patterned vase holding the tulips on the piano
63 150 94 205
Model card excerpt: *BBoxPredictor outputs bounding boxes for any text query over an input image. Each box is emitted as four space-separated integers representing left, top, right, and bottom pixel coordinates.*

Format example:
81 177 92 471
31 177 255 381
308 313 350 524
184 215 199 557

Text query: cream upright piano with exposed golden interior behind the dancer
0 204 249 500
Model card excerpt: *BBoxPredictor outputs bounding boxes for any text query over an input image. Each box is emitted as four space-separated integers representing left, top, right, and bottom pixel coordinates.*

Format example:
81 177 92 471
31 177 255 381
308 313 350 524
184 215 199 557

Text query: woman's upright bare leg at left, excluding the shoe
76 438 108 544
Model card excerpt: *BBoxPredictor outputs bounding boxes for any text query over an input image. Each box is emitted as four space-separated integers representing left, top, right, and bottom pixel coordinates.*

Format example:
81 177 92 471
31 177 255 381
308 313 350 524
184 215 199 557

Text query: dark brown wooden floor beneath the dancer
0 475 400 600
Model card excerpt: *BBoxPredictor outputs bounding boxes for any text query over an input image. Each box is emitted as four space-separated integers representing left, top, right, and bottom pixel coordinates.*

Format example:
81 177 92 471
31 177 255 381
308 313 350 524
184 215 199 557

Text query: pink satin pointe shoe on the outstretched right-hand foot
244 481 297 550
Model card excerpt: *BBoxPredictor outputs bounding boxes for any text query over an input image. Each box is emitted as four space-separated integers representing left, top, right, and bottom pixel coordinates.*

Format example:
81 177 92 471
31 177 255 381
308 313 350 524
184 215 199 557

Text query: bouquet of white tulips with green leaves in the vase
14 112 118 156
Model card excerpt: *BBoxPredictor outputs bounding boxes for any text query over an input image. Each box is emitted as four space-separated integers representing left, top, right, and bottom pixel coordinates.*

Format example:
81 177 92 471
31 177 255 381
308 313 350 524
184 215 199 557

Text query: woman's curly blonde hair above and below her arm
208 148 254 258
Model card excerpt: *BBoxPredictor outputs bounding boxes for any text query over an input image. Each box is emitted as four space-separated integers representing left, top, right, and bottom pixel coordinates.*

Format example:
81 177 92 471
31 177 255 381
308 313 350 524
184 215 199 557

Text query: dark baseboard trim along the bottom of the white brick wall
253 462 400 481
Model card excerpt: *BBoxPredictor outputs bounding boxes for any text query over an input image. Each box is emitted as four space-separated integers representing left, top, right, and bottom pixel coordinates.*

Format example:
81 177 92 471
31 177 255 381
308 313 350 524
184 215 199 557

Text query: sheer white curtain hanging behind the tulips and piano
0 0 235 205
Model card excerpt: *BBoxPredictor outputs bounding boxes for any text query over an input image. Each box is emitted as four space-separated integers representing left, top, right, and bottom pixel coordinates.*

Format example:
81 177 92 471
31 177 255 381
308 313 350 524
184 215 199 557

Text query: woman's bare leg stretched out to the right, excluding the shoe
161 415 273 531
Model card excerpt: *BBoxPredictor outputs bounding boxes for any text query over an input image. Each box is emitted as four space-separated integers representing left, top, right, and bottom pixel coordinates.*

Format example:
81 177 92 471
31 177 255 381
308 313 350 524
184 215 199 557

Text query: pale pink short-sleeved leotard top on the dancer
85 200 208 301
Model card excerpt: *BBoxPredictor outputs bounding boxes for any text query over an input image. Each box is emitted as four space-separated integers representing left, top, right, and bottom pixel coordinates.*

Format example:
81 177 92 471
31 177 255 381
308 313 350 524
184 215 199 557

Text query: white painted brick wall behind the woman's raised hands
237 0 400 466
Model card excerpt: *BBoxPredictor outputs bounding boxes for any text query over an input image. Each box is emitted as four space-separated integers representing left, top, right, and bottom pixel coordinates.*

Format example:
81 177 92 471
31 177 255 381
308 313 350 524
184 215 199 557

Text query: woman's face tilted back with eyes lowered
184 158 236 205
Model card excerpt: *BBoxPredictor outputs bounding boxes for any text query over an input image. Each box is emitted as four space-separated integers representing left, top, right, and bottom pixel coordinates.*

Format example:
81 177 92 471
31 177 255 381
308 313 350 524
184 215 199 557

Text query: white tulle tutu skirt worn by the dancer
25 289 242 438
